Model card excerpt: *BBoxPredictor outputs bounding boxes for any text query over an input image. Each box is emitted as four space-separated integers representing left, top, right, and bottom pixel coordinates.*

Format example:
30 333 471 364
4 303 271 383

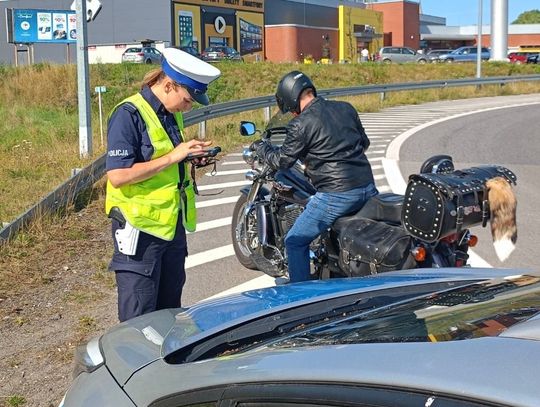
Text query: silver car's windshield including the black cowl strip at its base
166 276 540 363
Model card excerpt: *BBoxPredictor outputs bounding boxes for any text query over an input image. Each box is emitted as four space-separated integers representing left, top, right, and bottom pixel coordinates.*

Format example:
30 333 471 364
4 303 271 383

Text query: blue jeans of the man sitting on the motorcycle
285 184 378 283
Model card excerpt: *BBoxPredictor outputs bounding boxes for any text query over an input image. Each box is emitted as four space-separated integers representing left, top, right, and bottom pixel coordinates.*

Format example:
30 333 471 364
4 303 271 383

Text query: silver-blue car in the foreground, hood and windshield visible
61 268 540 407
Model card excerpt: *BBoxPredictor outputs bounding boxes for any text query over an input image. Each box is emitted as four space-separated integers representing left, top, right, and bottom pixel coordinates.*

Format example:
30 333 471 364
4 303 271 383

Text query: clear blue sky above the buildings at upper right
420 0 540 25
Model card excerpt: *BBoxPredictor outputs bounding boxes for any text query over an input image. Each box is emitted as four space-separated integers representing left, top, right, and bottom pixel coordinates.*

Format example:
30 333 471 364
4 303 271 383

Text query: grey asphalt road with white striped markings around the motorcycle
183 94 540 306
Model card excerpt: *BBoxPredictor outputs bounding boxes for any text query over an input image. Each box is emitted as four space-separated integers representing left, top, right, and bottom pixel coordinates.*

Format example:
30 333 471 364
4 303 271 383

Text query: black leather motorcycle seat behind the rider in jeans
333 193 403 230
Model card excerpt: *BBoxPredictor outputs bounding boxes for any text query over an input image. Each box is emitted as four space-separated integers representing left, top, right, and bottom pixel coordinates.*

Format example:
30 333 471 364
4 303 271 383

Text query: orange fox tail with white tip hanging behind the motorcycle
486 177 517 261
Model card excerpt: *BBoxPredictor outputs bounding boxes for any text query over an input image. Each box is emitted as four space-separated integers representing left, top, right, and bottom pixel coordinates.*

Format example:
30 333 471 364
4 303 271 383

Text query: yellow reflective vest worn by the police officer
105 93 197 241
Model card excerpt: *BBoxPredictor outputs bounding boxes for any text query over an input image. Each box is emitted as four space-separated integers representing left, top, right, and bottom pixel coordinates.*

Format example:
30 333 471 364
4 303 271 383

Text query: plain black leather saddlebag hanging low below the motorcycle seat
337 218 416 277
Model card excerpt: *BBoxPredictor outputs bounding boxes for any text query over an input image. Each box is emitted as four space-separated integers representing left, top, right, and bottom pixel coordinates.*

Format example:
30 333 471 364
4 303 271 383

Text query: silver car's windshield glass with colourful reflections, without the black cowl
272 276 540 347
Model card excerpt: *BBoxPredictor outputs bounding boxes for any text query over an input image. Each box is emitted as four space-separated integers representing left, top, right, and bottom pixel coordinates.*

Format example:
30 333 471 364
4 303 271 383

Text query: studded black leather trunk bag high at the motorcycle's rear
401 165 516 243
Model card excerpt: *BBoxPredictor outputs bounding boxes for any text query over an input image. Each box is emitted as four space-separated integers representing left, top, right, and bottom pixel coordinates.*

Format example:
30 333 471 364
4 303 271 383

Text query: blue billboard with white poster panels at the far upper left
6 9 77 44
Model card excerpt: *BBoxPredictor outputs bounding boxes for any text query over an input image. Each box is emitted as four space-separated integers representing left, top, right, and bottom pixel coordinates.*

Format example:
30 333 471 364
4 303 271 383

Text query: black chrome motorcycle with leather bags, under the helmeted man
231 121 516 279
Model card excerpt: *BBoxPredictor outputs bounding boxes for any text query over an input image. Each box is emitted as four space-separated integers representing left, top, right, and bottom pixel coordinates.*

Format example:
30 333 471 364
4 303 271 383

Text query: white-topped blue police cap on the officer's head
161 48 221 105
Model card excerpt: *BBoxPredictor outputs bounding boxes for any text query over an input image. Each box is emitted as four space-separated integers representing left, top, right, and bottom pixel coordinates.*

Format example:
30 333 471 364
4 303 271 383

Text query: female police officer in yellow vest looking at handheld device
105 48 221 321
